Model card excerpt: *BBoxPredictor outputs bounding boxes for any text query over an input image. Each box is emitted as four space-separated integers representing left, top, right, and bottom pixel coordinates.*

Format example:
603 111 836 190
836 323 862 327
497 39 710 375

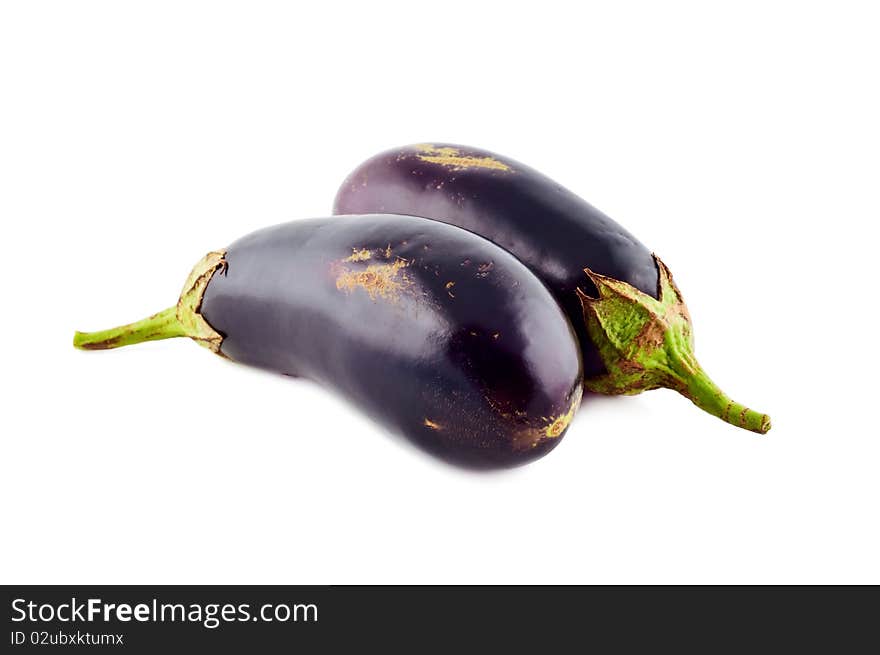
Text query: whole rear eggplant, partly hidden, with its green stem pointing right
333 144 770 434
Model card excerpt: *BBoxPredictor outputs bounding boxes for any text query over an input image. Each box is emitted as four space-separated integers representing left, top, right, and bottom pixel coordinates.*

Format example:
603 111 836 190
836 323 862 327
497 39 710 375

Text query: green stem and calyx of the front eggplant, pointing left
73 250 226 354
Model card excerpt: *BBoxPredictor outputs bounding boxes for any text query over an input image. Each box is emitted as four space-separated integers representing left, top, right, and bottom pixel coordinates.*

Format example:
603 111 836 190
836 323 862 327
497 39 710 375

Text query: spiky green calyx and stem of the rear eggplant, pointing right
578 256 770 434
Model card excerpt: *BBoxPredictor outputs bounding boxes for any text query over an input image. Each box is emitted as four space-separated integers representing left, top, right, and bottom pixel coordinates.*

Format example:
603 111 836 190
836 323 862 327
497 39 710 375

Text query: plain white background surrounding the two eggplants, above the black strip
0 0 880 583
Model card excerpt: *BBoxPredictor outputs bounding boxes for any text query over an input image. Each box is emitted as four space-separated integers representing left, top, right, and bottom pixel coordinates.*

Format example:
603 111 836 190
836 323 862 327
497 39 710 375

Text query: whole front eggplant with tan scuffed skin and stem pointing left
74 215 583 468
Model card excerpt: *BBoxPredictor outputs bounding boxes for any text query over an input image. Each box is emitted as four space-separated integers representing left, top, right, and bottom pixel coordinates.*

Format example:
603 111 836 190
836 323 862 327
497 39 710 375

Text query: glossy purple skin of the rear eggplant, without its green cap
333 144 659 377
